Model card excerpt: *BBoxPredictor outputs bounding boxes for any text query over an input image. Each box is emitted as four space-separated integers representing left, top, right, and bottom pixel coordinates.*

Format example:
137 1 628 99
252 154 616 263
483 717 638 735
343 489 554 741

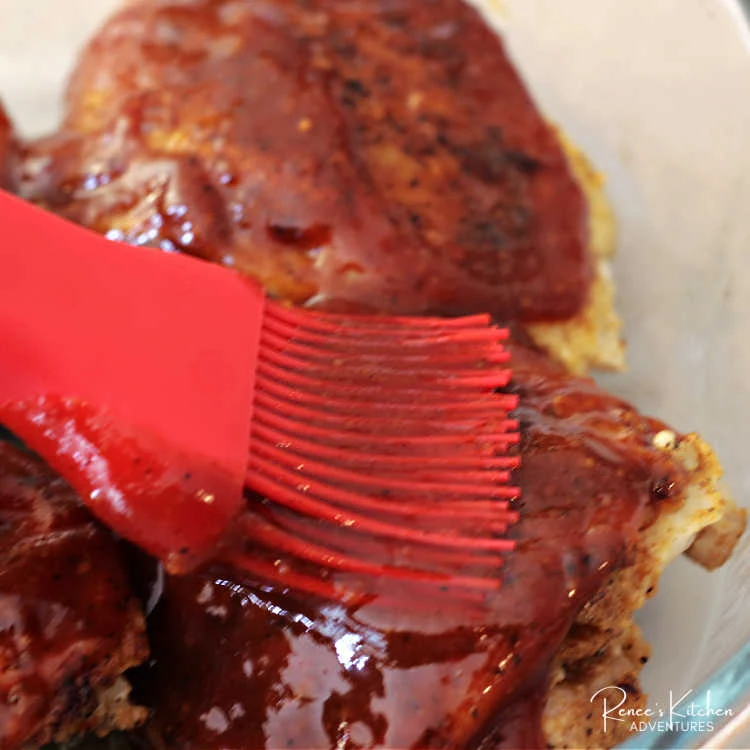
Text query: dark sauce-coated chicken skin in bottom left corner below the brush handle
0 443 148 750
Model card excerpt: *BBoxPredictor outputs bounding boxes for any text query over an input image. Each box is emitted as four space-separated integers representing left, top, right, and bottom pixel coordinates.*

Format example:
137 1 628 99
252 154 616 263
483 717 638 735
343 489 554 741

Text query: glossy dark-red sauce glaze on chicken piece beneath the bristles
138 347 686 750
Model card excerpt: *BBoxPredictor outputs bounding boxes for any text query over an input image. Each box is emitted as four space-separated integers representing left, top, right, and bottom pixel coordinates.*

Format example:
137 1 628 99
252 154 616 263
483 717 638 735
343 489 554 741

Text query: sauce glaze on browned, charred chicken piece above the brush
18 0 591 321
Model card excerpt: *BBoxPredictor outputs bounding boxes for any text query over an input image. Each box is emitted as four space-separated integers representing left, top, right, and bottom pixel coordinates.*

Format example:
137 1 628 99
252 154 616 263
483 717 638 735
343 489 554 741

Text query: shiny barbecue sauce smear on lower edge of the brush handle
0 396 242 573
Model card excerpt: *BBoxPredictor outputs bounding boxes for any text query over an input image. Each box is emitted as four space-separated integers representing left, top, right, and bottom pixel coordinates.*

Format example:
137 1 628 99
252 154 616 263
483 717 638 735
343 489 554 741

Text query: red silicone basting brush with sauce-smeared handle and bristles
0 193 518 593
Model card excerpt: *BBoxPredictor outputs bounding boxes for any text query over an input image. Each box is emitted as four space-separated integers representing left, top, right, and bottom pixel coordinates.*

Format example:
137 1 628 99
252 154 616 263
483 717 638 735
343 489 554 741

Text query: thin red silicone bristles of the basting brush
242 303 519 598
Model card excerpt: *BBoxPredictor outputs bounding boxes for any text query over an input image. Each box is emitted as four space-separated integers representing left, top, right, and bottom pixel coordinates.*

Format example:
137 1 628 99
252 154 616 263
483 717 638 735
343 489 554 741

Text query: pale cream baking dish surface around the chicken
0 0 750 747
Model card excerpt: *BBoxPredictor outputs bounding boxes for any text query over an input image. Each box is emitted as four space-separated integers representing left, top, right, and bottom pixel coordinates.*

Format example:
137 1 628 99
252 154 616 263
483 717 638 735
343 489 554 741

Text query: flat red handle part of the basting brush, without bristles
0 193 264 567
